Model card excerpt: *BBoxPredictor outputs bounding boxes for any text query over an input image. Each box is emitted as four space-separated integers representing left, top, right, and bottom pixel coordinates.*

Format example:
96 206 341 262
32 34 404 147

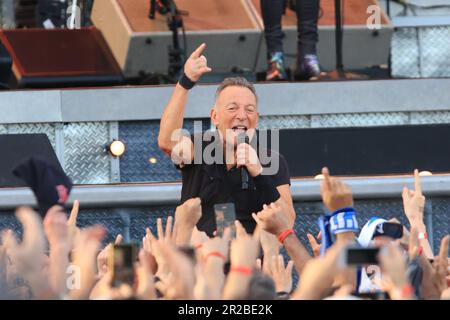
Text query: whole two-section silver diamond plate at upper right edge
391 27 450 78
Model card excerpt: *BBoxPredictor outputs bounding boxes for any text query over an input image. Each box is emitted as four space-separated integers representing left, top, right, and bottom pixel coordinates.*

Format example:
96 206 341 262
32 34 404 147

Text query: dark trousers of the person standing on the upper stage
261 0 320 57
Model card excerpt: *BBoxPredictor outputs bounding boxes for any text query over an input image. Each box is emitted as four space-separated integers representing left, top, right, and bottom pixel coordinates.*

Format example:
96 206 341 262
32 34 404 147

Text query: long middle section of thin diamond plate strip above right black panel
311 112 409 128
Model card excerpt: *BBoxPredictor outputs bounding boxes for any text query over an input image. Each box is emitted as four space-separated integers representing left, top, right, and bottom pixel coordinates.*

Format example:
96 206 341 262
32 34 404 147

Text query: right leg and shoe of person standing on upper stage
294 0 320 80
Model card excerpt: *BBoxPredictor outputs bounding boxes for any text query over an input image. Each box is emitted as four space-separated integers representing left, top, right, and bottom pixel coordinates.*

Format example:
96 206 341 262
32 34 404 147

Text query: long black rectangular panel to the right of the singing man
280 124 450 177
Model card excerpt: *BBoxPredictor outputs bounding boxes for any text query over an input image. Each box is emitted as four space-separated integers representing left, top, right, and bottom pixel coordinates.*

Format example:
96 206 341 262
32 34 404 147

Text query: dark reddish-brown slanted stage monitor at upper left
0 27 122 87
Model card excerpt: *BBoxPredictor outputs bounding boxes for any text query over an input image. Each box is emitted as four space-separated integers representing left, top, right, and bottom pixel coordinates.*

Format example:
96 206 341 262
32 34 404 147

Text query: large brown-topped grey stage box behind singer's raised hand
91 0 262 78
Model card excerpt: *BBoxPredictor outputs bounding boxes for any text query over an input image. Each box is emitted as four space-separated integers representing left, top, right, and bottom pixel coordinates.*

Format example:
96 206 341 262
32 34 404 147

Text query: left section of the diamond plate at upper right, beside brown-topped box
391 28 420 78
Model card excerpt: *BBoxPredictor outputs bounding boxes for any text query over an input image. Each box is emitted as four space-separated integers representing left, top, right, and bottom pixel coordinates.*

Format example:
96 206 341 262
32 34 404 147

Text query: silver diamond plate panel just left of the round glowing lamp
63 122 111 184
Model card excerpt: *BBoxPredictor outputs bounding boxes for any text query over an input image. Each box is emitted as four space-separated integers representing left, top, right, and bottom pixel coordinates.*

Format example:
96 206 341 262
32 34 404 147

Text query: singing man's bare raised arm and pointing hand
158 43 211 155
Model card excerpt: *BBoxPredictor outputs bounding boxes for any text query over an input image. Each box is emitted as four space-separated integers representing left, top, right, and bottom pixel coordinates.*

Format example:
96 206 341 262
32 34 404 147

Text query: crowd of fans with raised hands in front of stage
0 168 450 300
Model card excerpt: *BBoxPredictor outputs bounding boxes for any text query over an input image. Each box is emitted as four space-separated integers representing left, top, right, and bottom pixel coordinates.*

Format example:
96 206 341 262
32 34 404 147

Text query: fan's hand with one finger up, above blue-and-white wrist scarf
320 167 353 212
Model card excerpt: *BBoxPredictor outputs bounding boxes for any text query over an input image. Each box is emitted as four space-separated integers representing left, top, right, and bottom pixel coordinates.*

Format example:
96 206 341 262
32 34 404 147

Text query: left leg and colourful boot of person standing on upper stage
261 0 287 81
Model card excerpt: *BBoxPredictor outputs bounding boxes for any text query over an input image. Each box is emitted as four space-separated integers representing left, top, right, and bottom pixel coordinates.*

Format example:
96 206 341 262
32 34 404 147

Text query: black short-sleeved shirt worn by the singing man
178 131 290 236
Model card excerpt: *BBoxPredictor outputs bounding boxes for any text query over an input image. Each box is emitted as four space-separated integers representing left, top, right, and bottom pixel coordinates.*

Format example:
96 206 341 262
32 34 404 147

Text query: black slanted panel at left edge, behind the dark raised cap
0 133 62 187
